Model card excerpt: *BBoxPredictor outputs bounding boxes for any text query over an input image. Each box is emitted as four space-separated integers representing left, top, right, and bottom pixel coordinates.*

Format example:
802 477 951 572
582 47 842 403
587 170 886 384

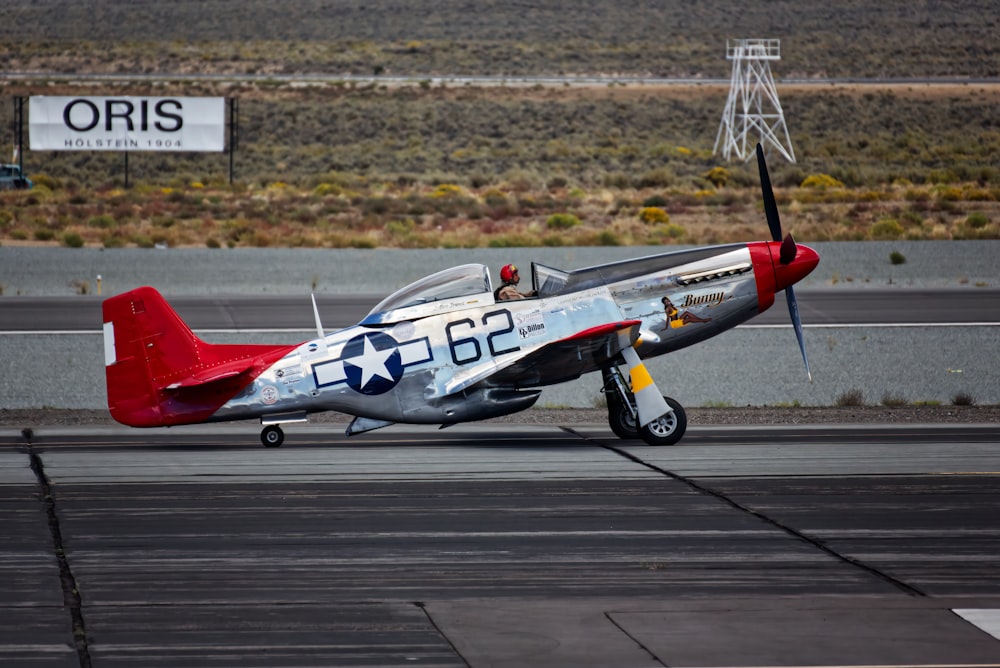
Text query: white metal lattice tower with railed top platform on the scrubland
712 39 795 162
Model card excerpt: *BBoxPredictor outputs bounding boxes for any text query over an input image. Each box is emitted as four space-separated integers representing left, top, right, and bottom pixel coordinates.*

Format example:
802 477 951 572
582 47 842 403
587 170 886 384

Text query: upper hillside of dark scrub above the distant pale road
0 0 1000 78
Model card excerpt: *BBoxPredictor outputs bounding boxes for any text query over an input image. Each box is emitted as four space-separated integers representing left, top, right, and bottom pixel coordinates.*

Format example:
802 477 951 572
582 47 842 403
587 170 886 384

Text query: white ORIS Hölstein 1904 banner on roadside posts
28 96 226 151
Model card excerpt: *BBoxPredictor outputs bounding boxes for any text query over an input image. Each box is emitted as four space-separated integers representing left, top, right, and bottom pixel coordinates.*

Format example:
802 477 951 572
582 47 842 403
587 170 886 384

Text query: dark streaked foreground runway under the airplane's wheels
0 423 1000 667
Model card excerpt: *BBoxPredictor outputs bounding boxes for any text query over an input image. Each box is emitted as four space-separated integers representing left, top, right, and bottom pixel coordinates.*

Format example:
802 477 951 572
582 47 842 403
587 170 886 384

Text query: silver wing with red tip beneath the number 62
439 320 642 396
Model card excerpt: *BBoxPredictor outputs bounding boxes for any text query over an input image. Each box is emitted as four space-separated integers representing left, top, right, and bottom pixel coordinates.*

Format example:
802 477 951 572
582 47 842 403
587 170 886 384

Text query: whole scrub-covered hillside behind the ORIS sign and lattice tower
0 0 1000 247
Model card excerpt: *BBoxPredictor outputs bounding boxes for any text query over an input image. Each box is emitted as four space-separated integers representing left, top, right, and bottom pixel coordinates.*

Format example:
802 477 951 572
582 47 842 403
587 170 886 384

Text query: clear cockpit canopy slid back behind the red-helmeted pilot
361 264 494 325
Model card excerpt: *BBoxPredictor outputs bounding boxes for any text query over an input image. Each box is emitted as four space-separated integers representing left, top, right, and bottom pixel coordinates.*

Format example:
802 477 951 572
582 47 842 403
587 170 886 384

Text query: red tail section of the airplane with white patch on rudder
104 287 295 427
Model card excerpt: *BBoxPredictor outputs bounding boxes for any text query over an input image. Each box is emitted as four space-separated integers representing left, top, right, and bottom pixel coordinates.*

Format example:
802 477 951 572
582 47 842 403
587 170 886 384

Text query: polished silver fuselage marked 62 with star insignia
210 244 773 424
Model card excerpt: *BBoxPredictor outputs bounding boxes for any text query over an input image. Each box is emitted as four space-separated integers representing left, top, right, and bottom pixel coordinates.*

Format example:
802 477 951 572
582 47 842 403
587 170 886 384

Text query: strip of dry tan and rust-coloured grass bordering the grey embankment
0 174 1000 248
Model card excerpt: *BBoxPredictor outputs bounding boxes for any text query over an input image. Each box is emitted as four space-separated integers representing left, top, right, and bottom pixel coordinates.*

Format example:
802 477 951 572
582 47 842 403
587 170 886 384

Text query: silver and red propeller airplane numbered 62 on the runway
103 145 819 447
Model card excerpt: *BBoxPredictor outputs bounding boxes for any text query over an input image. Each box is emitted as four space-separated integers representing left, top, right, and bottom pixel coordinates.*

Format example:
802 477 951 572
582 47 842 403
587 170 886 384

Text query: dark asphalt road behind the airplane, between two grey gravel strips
0 288 1000 332
